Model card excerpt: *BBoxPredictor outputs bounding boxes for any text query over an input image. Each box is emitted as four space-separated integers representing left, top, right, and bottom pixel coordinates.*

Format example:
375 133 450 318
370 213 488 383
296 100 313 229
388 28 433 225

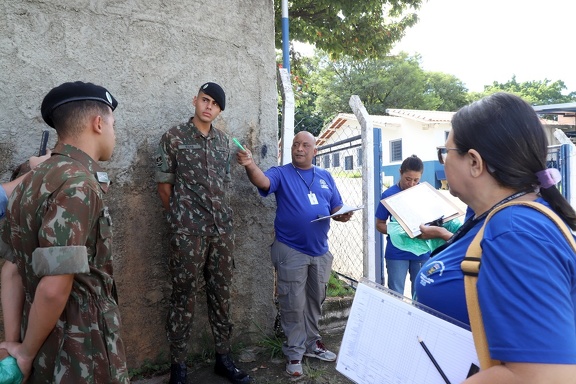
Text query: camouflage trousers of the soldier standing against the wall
166 234 234 363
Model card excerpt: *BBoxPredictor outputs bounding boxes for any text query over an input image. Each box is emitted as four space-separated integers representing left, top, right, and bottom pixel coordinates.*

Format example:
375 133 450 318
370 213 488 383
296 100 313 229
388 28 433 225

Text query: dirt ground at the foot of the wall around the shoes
132 329 353 384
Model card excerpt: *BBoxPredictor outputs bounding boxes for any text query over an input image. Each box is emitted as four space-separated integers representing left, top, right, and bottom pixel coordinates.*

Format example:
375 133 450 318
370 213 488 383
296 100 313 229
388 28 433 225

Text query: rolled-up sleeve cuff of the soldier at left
32 245 90 277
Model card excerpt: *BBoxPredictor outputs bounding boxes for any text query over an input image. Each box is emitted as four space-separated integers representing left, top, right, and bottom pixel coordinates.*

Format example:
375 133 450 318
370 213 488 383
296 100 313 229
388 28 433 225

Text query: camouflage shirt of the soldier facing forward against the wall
156 119 232 236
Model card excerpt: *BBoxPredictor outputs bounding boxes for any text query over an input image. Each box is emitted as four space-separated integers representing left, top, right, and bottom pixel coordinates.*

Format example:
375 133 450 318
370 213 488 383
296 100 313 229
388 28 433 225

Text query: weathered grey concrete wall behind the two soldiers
0 0 277 368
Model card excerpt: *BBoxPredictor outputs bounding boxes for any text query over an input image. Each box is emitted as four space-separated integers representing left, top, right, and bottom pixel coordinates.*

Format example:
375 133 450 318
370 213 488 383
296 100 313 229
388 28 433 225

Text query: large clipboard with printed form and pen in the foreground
336 278 480 384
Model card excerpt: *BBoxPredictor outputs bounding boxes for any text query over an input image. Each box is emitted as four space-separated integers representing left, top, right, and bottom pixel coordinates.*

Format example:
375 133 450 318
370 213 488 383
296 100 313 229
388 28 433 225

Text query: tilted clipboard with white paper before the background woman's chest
380 182 464 238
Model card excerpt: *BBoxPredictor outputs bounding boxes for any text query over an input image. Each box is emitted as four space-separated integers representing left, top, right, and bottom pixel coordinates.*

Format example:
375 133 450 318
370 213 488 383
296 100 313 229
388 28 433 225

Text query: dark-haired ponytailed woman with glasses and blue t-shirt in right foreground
415 93 576 384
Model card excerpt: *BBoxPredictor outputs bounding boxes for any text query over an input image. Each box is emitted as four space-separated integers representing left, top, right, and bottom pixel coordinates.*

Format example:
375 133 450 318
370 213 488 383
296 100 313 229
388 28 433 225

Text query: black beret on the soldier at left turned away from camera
40 81 118 128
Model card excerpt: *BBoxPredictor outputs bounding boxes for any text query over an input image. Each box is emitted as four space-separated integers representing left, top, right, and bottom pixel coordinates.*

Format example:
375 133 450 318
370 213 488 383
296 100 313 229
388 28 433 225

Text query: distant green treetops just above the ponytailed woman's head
469 76 576 105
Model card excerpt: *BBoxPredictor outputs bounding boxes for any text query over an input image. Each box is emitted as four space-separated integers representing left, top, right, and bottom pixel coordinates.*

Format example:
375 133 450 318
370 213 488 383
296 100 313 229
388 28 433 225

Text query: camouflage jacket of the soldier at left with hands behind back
1 145 130 384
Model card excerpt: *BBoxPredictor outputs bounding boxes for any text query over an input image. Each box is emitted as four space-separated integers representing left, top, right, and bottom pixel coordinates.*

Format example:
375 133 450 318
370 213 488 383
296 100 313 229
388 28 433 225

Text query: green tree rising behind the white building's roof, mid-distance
310 52 467 117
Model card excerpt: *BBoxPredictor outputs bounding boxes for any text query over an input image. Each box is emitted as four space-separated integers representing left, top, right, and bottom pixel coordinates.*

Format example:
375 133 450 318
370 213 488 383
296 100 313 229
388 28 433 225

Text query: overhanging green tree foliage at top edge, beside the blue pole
274 0 422 59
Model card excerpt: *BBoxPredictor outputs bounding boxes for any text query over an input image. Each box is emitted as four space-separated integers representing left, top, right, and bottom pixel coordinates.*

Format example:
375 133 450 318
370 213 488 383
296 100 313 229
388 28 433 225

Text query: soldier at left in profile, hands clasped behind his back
0 82 130 384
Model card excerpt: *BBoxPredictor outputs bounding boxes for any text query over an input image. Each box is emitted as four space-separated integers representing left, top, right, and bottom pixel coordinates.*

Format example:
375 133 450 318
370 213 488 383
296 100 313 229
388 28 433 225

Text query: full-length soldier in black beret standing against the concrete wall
156 82 252 384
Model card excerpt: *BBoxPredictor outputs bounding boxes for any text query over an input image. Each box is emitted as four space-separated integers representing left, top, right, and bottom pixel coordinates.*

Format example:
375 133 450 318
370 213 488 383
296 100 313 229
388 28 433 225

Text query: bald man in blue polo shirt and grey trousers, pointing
236 131 352 376
